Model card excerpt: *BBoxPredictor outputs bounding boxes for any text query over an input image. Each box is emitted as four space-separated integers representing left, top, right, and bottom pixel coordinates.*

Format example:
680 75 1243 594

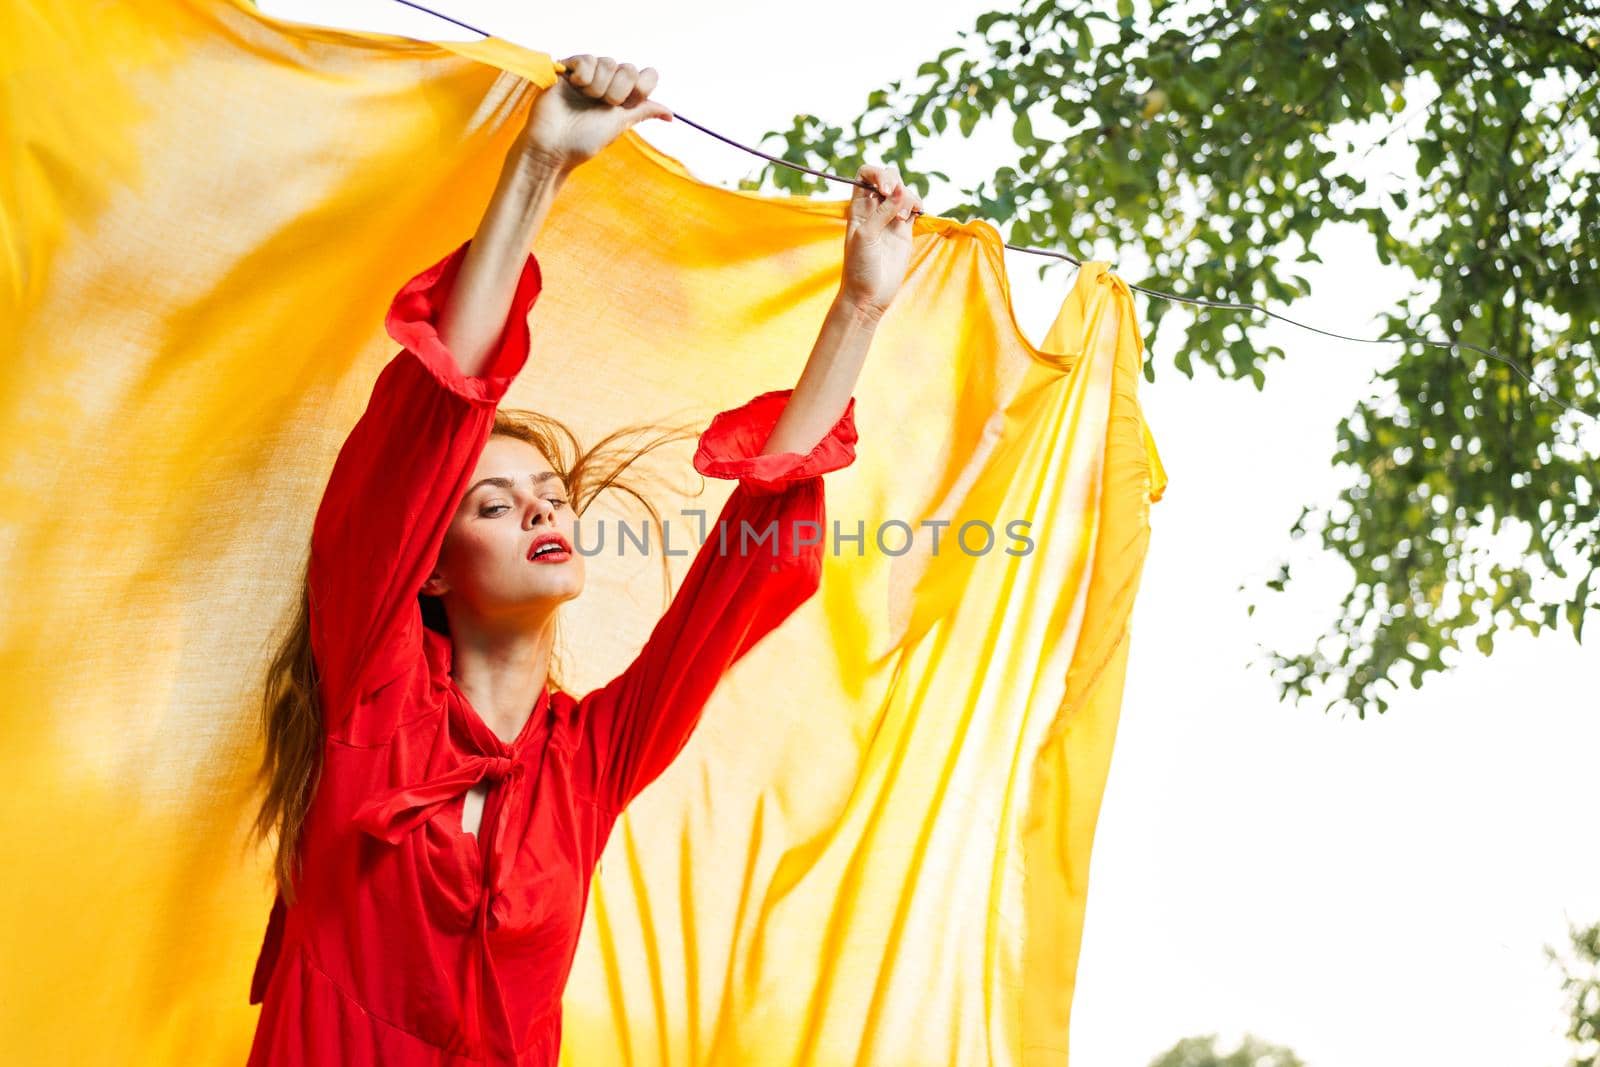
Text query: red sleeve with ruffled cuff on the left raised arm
309 240 541 726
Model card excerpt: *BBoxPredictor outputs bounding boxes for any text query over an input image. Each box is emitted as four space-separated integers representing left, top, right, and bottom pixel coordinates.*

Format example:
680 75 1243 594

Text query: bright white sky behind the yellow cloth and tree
261 0 1600 1067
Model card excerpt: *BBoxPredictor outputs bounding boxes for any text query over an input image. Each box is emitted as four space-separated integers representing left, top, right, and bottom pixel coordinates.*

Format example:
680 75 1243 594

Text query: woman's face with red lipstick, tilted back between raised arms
422 435 584 625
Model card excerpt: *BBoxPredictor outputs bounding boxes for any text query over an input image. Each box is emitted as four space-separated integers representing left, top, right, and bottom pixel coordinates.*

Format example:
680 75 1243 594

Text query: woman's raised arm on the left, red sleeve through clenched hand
307 56 666 736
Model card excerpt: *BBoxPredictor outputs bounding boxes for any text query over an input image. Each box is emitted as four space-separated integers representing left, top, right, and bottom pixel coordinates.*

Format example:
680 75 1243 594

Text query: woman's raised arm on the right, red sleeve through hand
578 166 922 816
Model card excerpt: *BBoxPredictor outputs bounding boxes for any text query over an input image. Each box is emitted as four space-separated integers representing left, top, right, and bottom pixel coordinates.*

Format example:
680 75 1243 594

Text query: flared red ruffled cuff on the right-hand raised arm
694 389 856 496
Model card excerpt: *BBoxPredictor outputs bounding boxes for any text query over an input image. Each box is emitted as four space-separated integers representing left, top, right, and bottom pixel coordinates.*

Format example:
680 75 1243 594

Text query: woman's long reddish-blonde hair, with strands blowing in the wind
253 410 699 904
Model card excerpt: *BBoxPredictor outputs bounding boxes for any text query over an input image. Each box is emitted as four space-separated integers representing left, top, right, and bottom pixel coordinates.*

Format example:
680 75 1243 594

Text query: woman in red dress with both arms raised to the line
251 54 920 1065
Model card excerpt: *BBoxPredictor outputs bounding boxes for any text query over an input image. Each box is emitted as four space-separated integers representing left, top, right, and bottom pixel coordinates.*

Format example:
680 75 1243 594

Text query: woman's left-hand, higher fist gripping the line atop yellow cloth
522 54 672 173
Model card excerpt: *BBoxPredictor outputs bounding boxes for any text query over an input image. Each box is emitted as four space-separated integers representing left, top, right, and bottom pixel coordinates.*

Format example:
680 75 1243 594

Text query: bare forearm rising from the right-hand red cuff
762 291 882 454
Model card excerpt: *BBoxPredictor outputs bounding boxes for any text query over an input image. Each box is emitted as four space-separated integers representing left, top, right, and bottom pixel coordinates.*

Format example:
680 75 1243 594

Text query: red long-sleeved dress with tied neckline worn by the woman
250 243 856 1067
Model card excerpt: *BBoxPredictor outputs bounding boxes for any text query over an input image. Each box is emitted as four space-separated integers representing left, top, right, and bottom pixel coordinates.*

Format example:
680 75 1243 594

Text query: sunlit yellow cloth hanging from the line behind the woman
0 0 1165 1065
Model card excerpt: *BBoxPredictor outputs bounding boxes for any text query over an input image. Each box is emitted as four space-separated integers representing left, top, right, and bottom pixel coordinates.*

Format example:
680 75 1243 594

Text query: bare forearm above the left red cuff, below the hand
438 138 566 376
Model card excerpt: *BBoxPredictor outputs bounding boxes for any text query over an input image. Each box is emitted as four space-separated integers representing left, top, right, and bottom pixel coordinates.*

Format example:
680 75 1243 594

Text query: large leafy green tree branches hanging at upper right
744 0 1600 715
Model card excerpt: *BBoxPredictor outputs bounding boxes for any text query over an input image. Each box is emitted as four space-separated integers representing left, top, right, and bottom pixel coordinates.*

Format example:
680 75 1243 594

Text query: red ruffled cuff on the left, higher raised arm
384 238 542 406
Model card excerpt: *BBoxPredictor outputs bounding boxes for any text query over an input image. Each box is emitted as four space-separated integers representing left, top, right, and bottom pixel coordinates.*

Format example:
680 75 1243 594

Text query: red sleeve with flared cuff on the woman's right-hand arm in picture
578 389 856 813
